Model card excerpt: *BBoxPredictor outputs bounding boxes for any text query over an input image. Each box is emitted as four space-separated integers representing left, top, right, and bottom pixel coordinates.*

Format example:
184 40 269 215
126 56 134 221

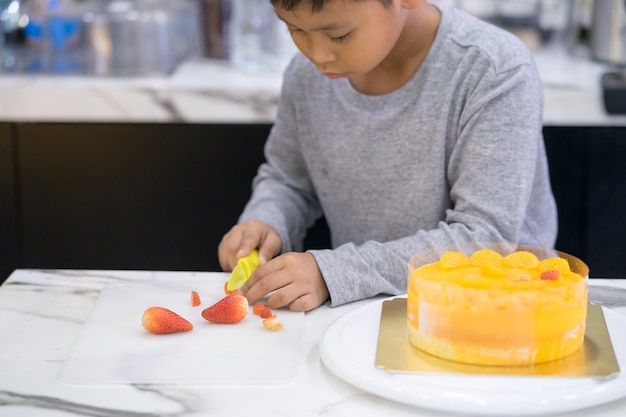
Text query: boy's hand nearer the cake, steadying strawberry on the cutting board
240 252 329 311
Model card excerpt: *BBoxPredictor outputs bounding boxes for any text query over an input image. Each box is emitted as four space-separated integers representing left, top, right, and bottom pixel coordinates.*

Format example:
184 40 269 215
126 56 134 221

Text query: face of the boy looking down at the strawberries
275 0 421 79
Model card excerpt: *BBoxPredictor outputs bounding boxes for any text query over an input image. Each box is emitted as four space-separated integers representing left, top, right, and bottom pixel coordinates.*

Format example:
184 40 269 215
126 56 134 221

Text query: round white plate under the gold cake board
320 301 626 416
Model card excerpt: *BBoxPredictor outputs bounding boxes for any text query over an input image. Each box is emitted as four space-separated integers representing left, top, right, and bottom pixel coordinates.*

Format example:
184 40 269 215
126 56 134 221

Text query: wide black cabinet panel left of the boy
17 124 269 270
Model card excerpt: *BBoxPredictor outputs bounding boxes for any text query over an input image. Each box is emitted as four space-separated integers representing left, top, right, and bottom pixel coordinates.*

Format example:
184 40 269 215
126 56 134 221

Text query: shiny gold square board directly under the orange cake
376 297 619 378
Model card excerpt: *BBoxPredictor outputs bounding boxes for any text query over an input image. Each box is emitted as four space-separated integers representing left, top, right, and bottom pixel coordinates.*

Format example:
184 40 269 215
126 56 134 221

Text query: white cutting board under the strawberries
58 281 304 385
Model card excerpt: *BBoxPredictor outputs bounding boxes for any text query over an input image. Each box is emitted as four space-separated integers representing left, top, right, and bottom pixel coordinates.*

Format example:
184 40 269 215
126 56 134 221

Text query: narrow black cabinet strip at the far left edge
0 123 18 283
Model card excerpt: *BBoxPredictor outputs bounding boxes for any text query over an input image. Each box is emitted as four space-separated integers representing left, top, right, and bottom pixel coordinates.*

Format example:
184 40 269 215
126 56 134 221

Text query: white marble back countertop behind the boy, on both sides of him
0 47 626 126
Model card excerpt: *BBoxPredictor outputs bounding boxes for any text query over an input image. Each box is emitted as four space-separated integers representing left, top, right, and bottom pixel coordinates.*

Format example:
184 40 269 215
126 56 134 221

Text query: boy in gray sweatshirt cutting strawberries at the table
218 0 557 311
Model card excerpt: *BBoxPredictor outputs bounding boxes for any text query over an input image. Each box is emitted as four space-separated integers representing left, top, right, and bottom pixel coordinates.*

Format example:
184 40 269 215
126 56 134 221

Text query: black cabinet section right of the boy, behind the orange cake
544 127 626 278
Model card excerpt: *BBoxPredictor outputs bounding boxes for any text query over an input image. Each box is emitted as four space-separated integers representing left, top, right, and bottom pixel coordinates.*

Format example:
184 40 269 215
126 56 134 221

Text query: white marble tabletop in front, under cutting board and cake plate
0 270 626 417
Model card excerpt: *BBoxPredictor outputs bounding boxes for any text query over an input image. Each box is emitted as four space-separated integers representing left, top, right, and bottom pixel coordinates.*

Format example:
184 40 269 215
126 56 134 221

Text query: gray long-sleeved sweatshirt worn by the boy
240 7 557 306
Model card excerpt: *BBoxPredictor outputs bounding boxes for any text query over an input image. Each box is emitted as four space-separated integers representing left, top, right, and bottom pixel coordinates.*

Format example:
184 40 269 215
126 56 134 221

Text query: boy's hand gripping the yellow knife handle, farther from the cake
217 220 283 271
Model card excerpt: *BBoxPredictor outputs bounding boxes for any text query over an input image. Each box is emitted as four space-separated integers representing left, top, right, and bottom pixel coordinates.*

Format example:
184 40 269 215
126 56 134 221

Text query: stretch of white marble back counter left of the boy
0 60 282 123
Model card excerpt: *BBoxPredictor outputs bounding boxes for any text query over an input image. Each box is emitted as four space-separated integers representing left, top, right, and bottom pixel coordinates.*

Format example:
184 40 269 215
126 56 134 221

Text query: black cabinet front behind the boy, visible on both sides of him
0 123 626 278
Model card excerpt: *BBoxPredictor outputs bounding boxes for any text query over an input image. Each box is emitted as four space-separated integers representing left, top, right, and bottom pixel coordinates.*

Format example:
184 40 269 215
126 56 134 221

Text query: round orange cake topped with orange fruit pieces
407 249 587 366
